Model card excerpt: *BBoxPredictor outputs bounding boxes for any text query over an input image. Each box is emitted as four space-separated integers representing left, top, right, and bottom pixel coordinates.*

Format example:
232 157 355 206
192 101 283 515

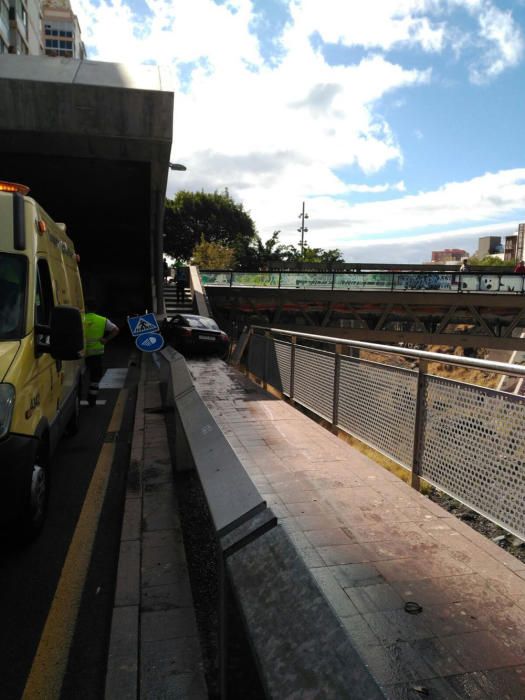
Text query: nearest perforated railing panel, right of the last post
421 376 525 536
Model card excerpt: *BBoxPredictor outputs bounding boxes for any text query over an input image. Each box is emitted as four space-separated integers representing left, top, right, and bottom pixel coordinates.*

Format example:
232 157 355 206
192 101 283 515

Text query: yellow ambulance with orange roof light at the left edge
0 182 84 539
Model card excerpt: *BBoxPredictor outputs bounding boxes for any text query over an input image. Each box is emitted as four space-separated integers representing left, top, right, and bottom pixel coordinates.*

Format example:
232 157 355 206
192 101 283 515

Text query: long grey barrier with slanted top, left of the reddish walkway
160 348 384 700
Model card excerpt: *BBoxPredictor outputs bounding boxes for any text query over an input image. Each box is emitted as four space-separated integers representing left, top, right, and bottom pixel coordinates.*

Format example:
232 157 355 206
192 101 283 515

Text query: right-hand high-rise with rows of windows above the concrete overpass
42 0 86 58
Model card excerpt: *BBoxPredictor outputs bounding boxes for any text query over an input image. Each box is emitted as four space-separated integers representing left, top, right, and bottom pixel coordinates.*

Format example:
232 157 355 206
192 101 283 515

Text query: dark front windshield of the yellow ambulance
0 253 27 340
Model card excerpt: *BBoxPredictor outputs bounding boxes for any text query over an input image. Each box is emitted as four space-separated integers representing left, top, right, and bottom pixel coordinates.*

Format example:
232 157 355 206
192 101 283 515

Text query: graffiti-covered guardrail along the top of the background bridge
200 270 525 294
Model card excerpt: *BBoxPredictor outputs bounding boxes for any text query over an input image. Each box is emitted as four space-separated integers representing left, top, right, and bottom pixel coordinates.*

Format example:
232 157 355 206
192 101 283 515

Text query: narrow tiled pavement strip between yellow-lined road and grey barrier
105 355 208 700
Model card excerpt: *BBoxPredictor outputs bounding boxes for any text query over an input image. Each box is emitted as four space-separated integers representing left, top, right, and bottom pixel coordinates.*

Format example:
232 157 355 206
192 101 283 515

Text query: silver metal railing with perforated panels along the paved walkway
245 326 525 539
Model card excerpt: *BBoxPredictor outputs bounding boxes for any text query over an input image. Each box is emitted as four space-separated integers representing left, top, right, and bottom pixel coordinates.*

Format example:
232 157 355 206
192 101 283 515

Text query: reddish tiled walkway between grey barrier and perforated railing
189 360 525 700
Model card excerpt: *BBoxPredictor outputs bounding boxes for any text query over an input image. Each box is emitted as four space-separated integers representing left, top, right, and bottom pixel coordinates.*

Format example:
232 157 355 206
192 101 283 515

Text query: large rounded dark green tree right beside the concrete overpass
164 189 257 260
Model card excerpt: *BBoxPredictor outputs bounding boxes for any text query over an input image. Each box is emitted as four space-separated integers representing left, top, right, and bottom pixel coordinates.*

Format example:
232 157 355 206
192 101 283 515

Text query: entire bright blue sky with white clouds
73 0 525 262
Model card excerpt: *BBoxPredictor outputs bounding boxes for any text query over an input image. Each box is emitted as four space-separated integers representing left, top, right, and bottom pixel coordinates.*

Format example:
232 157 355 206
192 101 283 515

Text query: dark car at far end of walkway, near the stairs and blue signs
162 314 230 357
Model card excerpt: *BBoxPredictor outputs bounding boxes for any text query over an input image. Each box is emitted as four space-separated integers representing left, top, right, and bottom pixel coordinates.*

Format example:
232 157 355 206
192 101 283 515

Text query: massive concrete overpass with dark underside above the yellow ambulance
0 55 173 318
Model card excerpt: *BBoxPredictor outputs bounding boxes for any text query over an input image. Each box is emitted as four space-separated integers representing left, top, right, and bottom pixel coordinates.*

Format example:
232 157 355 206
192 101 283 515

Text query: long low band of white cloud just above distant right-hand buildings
232 169 525 262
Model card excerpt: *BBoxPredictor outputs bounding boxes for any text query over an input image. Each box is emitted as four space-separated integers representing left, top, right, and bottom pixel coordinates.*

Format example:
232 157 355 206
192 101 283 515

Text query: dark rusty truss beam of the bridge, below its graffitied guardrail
206 287 525 350
